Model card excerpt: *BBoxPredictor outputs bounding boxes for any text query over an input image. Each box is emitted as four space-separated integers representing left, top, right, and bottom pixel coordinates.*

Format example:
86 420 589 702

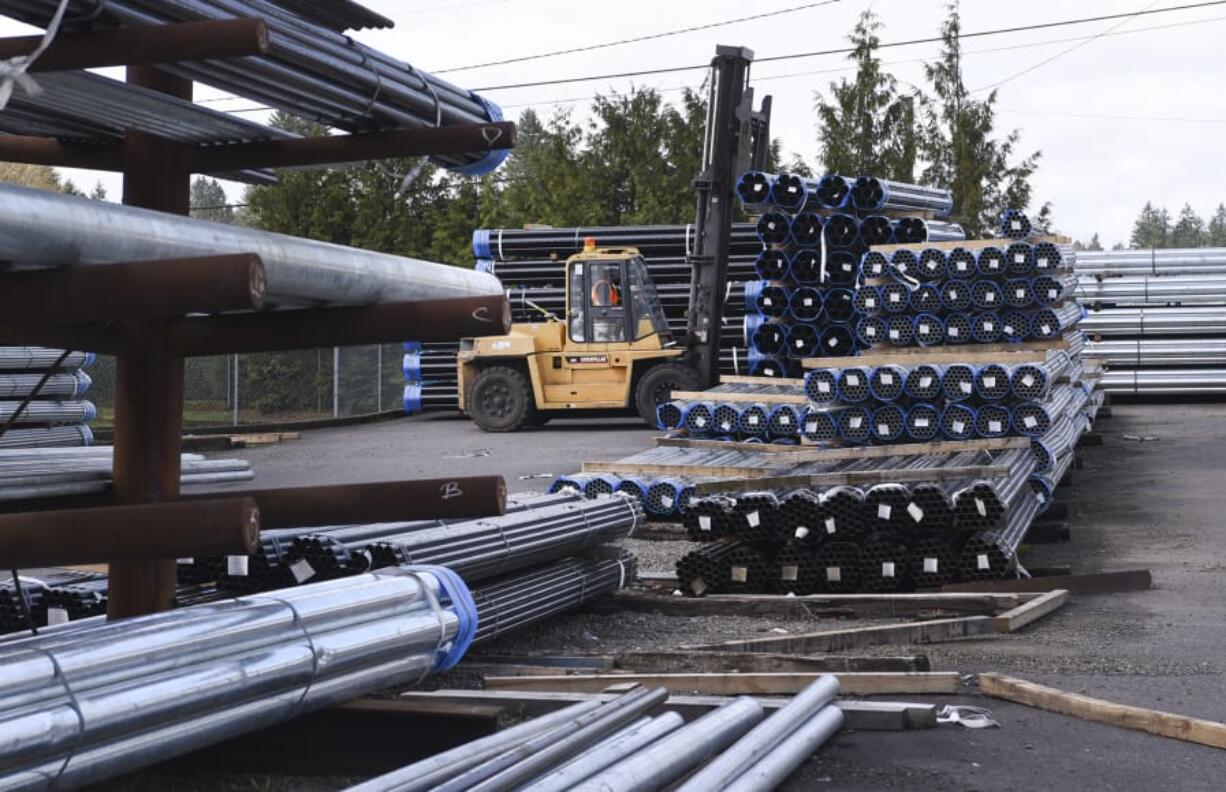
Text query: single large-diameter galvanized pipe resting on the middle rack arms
0 184 503 305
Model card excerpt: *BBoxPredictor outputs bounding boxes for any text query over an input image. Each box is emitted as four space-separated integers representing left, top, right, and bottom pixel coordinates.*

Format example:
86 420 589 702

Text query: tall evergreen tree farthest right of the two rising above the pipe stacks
920 2 1051 239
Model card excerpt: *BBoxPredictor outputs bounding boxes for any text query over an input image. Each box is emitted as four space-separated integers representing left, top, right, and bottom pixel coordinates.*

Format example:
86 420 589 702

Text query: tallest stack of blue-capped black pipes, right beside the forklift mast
737 170 965 376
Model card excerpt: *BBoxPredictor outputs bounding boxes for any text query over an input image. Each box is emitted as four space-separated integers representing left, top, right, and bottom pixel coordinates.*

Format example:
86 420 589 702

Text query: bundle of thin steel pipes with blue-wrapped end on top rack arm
0 0 506 175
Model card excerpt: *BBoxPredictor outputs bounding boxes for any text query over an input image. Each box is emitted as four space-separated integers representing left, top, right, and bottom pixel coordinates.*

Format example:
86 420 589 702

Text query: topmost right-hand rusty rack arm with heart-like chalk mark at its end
191 121 516 173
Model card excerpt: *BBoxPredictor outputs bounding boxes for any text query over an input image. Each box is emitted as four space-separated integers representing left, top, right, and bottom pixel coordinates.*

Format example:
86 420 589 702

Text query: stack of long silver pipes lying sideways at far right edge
1076 248 1226 397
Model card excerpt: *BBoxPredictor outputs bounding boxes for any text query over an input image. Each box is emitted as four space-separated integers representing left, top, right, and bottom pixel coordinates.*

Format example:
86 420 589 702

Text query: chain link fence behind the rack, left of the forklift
89 343 405 429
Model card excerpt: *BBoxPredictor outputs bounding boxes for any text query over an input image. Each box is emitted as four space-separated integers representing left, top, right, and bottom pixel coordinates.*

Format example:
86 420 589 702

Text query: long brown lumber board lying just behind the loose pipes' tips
485 671 961 695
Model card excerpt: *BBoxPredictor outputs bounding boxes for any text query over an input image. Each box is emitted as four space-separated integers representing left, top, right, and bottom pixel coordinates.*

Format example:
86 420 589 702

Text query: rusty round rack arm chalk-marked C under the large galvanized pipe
168 294 511 357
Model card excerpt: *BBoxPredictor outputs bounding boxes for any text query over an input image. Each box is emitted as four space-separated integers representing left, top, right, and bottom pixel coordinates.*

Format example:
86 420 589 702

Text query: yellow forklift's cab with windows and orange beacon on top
566 247 672 347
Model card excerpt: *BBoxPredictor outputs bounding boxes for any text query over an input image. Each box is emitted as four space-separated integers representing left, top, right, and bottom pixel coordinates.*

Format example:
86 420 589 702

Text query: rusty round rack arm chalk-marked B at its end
183 476 506 530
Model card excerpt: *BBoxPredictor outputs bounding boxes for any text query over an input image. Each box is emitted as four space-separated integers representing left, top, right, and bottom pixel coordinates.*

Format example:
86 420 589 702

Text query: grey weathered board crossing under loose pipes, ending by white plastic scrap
396 690 937 732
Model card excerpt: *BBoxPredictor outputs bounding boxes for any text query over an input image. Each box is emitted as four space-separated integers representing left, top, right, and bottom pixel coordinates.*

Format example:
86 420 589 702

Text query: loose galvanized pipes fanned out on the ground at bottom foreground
349 676 842 792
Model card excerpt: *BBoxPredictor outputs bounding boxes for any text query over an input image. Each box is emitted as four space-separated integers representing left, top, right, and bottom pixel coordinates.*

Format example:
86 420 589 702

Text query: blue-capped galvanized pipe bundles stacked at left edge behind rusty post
0 347 97 449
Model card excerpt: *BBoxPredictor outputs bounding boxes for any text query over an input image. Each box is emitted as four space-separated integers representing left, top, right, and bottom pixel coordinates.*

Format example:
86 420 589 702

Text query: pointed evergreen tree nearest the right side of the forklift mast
815 9 917 181
